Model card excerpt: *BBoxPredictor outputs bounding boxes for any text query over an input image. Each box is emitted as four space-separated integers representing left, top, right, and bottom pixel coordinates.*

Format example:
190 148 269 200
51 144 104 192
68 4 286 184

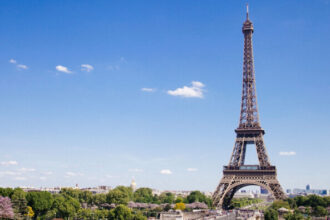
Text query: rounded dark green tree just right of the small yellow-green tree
26 191 54 216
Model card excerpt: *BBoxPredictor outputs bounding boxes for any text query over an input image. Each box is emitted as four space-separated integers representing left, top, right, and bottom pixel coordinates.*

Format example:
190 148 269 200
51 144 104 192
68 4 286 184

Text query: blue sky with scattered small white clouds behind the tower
0 0 330 191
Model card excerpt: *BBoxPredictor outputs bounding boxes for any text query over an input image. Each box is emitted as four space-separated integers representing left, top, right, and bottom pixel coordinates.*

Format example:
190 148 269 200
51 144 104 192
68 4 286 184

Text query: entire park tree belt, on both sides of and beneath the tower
0 186 330 220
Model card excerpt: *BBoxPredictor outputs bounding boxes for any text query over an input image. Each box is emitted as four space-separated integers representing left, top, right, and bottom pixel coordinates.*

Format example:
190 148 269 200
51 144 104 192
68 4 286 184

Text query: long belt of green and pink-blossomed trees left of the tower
0 186 212 220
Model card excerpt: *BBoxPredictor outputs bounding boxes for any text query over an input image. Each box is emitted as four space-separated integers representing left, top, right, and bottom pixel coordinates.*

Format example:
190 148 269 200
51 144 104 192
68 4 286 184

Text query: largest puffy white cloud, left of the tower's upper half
167 81 205 98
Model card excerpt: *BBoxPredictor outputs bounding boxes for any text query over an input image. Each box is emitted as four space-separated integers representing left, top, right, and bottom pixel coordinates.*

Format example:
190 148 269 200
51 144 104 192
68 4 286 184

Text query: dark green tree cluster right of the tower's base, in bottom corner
264 195 330 220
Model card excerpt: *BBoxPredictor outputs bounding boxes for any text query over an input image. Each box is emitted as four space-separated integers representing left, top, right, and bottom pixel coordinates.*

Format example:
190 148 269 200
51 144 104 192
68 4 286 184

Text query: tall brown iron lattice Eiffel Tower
213 6 286 209
